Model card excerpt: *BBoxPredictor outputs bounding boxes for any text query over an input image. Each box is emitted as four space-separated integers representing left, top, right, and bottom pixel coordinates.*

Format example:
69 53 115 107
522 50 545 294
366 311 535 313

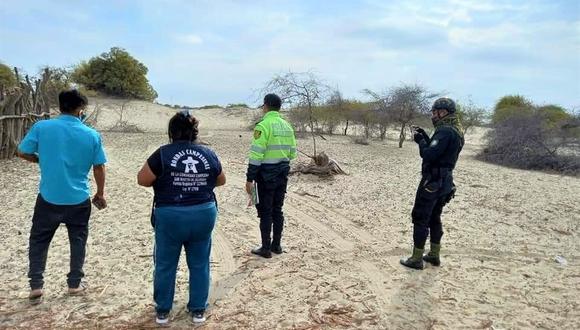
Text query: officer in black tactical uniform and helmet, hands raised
401 97 464 269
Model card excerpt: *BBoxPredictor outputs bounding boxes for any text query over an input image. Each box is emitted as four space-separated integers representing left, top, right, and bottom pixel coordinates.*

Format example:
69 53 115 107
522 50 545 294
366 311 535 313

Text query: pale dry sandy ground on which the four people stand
0 102 580 329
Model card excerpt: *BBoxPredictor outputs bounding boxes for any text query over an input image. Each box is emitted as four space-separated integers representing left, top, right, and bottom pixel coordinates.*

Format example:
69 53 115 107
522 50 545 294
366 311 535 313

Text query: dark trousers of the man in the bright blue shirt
28 194 91 290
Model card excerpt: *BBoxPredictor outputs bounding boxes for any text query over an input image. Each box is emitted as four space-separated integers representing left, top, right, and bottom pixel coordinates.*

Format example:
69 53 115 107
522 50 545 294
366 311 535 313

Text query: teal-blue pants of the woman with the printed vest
153 202 217 313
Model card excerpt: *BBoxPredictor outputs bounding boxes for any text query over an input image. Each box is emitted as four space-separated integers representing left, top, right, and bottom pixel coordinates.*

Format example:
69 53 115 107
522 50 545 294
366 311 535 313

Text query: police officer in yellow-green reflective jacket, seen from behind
246 94 296 258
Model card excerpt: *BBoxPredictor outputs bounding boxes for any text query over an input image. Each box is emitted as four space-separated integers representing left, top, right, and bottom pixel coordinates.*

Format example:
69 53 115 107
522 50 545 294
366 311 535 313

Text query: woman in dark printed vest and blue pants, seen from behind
137 112 226 324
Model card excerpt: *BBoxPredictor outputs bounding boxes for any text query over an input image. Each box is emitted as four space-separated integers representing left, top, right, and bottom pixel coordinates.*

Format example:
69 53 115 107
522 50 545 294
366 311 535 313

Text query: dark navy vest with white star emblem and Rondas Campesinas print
147 141 222 207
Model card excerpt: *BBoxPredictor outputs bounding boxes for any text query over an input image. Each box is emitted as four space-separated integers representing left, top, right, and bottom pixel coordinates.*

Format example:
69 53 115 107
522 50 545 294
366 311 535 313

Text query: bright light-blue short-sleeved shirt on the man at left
18 114 107 205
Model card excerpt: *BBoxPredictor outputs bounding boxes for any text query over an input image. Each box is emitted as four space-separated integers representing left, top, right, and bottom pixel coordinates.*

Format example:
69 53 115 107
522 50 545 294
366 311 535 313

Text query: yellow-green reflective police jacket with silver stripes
250 111 296 166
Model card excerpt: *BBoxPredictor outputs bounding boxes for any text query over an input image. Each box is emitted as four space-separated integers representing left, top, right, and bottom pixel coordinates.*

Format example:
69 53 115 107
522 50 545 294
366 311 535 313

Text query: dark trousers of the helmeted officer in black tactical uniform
411 180 454 249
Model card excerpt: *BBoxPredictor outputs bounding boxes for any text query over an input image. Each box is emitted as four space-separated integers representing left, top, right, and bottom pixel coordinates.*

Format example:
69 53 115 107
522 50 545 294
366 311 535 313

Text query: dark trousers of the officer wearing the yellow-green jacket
256 170 288 249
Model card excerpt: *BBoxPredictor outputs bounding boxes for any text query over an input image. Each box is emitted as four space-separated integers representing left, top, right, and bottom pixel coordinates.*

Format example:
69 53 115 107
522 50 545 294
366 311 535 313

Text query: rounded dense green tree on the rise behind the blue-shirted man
72 47 157 101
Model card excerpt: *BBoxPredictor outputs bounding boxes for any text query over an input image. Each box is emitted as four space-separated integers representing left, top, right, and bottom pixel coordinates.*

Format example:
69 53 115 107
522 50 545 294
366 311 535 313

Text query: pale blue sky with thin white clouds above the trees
0 0 580 111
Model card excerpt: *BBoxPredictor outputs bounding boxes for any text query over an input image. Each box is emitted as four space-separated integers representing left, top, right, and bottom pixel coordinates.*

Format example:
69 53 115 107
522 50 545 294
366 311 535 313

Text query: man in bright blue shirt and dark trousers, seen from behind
18 90 107 304
